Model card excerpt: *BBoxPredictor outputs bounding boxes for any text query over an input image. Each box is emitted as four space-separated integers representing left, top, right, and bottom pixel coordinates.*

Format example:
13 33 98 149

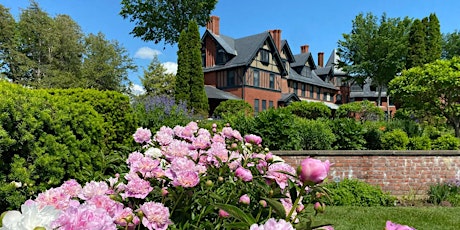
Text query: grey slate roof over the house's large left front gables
202 30 287 75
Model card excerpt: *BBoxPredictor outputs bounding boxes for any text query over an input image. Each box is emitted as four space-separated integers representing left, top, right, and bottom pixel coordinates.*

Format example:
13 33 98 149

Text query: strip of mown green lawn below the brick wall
313 206 460 230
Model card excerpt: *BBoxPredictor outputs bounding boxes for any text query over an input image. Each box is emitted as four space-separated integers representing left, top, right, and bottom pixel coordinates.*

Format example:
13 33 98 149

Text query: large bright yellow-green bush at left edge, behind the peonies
0 82 107 210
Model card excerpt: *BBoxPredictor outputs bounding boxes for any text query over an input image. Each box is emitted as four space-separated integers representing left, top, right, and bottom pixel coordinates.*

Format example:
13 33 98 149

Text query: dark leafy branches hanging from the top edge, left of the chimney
120 0 217 45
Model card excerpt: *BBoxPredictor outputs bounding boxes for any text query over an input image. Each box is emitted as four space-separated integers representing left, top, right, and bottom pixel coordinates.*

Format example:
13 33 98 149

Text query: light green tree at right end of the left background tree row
81 32 137 92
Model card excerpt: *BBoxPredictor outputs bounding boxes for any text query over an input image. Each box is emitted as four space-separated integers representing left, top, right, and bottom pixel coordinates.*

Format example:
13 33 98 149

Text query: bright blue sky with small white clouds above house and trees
0 0 460 91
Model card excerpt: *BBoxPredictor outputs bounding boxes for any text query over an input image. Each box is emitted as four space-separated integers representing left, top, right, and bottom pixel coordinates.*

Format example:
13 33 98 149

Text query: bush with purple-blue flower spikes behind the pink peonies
133 95 193 130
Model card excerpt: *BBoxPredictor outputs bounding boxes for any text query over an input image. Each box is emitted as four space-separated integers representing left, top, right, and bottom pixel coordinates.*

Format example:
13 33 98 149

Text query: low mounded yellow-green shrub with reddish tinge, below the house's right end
335 100 384 121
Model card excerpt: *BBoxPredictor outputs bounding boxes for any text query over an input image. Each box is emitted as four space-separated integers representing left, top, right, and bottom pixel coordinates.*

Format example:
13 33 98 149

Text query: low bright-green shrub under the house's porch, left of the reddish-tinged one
287 101 331 119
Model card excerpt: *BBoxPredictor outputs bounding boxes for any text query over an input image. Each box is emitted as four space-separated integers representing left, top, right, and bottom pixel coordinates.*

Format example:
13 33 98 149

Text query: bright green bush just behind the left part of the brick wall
295 118 336 150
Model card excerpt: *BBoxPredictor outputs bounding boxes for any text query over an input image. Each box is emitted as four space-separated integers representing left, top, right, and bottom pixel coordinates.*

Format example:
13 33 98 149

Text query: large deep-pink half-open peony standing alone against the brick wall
298 157 331 185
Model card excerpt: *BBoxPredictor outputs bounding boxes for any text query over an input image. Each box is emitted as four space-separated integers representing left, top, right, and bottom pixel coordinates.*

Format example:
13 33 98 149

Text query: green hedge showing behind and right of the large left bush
44 89 138 150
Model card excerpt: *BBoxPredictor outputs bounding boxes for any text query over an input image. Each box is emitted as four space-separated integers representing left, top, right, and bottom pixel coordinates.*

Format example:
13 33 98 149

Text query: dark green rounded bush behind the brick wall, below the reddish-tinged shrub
331 118 366 150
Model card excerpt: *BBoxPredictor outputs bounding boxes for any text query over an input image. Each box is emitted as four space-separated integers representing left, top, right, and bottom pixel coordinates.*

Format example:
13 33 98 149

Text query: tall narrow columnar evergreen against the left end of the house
174 21 209 115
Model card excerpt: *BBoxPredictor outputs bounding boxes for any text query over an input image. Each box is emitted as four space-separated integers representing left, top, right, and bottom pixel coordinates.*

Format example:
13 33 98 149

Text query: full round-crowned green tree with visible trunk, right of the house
338 13 411 106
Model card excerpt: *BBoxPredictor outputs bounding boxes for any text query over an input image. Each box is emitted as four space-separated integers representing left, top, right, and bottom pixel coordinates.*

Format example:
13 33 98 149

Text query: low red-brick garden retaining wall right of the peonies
273 151 460 196
